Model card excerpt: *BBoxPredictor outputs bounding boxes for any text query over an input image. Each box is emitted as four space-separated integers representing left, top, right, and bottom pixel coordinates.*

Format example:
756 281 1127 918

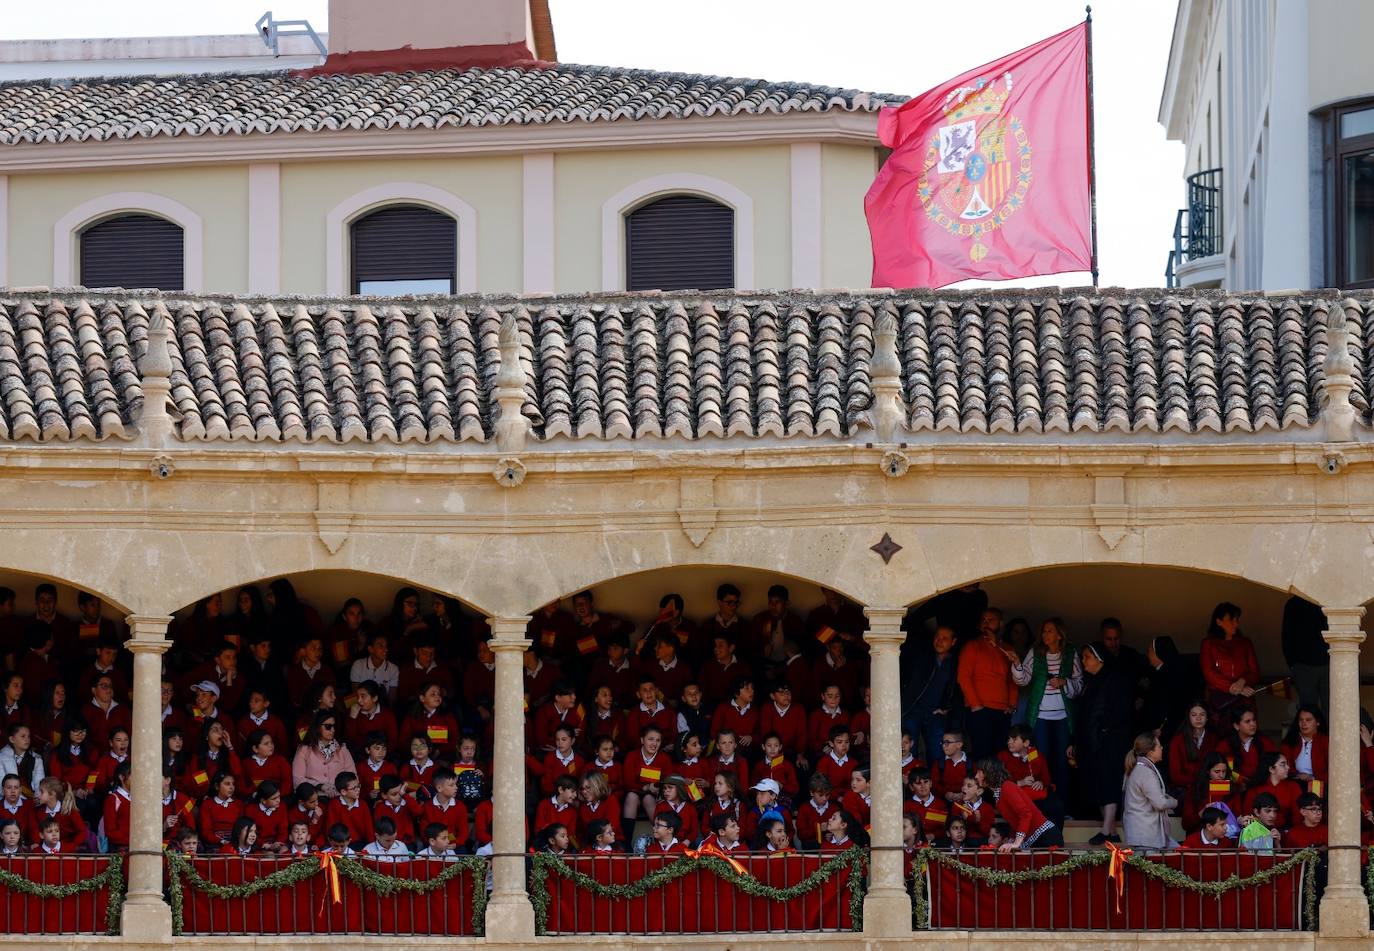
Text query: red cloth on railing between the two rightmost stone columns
929 852 1303 930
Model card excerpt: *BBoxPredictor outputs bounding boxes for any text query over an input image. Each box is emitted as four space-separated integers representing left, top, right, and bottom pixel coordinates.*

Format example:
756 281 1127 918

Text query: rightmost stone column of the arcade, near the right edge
1322 606 1370 937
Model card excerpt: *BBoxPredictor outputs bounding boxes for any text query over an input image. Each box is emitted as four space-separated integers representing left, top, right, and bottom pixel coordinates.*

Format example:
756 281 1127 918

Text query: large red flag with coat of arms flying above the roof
864 23 1092 287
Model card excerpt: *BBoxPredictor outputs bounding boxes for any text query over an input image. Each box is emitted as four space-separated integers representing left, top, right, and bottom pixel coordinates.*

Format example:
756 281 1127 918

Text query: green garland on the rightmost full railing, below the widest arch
911 847 1324 930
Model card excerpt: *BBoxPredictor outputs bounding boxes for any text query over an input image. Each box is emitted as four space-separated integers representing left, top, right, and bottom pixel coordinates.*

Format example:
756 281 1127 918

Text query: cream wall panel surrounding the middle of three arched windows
282 155 522 294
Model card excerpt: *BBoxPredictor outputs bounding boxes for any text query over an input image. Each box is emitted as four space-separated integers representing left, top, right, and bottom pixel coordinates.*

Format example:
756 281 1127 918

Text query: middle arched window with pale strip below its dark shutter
349 205 458 294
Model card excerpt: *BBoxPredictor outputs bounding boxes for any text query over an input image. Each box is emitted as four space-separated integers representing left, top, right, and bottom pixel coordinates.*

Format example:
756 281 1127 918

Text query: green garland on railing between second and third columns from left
529 848 867 935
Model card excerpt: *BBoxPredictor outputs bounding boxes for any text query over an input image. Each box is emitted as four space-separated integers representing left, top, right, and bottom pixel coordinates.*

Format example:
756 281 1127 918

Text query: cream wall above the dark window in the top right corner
1307 0 1374 109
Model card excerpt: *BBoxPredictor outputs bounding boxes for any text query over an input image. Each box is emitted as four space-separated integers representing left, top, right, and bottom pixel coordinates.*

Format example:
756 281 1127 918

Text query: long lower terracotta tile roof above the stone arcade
0 290 1357 444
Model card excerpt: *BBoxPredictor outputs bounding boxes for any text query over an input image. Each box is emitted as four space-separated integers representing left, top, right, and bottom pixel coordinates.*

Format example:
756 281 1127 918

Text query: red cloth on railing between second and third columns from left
548 855 853 935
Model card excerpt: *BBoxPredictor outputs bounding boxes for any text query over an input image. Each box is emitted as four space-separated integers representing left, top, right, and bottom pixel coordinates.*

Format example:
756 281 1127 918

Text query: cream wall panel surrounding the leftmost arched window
8 165 249 293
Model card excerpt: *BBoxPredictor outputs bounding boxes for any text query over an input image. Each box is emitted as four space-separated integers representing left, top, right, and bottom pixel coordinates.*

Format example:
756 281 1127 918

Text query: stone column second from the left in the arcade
486 617 534 944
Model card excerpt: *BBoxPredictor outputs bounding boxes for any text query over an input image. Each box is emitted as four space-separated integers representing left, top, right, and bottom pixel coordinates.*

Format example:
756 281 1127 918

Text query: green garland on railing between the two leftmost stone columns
166 851 486 935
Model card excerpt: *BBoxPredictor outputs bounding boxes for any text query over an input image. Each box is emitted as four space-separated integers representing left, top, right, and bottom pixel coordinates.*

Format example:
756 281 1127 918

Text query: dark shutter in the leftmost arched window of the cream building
81 214 185 290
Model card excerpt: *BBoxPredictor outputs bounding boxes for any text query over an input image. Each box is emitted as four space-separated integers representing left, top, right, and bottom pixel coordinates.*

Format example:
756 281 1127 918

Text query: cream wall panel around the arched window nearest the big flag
554 146 791 293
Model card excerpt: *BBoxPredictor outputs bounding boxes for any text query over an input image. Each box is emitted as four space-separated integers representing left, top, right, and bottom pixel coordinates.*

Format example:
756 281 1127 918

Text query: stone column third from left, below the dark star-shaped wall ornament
863 607 911 939
